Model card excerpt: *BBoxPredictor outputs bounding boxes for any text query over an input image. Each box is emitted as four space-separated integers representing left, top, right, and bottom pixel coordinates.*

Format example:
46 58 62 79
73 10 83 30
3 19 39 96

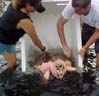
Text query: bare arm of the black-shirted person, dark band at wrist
17 19 45 51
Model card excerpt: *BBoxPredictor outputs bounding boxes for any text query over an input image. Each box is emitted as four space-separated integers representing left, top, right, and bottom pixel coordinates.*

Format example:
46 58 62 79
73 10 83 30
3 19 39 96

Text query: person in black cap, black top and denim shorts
0 0 46 84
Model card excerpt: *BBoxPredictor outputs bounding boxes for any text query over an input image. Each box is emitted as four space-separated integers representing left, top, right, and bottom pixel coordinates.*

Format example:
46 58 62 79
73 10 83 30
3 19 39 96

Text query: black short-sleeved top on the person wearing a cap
0 4 30 44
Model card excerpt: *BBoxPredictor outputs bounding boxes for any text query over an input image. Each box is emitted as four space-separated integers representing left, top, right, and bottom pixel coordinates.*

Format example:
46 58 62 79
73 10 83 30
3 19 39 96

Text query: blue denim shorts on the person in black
0 43 16 54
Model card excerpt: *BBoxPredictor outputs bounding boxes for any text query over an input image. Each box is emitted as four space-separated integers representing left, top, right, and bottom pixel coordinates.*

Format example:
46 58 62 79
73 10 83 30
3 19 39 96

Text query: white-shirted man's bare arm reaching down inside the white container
57 16 71 57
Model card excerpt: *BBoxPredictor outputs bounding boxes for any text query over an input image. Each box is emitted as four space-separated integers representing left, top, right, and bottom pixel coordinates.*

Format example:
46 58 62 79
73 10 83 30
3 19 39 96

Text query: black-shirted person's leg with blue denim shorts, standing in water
0 43 16 83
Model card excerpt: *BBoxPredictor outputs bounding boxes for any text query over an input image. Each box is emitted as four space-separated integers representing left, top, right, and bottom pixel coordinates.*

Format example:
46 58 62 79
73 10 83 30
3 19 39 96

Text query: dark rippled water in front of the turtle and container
0 64 99 96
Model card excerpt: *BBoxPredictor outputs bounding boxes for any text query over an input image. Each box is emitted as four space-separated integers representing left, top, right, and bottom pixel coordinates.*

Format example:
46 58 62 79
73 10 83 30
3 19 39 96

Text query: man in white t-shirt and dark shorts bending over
57 0 99 70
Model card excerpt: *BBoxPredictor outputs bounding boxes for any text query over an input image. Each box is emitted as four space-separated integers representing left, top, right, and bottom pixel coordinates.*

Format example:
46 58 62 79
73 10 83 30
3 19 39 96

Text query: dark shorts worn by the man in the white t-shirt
82 23 99 53
